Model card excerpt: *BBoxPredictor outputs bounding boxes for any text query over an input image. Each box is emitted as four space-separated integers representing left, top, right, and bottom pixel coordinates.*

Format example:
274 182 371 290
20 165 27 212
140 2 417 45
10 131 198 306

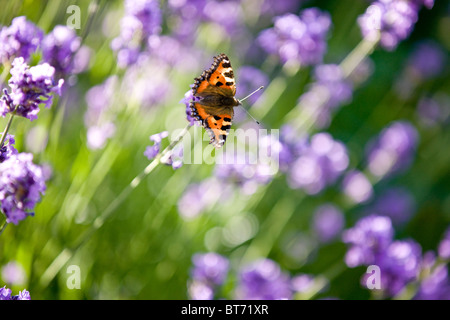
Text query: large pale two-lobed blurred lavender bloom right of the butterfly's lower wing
287 132 349 194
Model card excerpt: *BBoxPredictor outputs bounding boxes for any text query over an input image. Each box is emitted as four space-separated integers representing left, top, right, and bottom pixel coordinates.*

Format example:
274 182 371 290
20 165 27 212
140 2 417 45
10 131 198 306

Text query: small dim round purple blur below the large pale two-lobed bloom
312 204 345 243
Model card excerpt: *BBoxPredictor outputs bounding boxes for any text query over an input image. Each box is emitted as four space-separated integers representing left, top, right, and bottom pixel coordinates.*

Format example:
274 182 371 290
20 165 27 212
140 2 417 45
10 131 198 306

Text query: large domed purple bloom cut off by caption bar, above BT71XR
236 259 292 300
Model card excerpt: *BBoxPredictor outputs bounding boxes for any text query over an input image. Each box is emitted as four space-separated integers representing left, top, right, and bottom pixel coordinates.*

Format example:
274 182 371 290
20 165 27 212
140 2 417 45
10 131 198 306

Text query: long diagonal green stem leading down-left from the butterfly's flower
40 125 191 287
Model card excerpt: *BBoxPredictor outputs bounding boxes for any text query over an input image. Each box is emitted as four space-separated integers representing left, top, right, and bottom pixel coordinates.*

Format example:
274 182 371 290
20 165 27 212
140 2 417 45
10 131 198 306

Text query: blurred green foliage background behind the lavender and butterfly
0 0 450 299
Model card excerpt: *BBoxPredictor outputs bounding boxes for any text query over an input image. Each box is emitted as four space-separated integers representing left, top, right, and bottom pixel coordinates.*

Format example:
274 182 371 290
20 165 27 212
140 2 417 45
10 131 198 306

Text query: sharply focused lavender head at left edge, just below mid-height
0 153 46 224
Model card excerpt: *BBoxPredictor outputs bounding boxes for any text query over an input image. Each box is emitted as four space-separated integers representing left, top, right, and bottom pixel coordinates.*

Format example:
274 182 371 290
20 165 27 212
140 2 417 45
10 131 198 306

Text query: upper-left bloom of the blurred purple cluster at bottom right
342 215 394 268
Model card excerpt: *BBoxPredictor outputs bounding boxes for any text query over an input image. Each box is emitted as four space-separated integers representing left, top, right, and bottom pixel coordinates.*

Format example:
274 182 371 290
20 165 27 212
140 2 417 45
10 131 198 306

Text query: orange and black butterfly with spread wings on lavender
189 53 241 148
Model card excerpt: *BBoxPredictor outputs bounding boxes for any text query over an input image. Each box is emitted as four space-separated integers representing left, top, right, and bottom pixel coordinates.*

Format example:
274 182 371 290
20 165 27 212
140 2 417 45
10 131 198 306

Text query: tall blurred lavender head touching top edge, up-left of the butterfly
111 0 162 68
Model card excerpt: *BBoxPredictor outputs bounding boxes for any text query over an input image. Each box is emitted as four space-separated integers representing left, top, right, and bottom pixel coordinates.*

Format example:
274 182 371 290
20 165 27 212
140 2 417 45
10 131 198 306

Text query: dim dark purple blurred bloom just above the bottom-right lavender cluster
370 188 415 226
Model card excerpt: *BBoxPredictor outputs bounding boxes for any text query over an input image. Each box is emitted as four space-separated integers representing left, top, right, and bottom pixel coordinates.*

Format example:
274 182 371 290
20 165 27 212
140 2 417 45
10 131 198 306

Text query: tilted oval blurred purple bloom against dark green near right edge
367 121 418 177
